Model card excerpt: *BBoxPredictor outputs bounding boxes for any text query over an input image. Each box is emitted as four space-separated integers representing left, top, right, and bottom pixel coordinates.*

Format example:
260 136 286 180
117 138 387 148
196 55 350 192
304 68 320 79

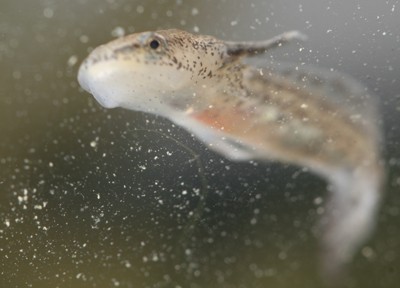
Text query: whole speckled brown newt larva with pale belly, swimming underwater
79 30 383 275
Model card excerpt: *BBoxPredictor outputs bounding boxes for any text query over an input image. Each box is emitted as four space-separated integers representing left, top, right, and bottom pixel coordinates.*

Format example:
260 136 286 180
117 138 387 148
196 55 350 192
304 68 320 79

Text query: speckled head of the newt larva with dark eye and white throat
78 30 227 114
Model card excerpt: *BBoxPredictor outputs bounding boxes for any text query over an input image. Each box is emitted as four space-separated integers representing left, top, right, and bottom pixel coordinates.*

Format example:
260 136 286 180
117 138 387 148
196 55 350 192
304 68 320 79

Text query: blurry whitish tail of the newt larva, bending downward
321 163 384 281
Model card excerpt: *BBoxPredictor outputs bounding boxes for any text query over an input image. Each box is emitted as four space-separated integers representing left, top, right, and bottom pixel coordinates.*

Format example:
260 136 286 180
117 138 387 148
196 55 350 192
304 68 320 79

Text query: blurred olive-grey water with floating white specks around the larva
0 0 400 287
